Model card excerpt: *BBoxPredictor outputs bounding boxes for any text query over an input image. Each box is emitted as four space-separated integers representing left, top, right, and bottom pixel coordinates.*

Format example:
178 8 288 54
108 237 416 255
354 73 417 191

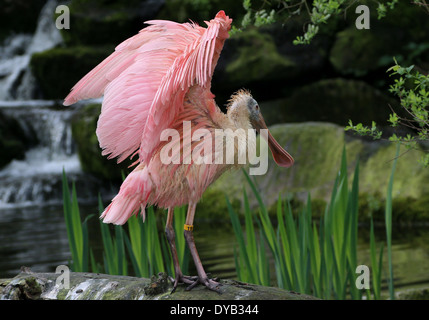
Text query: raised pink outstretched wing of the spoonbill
64 11 232 162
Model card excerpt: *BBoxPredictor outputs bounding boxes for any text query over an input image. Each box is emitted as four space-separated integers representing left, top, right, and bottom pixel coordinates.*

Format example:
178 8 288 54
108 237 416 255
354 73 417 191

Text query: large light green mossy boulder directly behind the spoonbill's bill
203 122 361 220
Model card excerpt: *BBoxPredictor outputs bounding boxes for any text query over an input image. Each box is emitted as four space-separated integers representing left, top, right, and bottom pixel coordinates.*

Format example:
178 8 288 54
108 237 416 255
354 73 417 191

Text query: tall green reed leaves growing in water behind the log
63 147 399 299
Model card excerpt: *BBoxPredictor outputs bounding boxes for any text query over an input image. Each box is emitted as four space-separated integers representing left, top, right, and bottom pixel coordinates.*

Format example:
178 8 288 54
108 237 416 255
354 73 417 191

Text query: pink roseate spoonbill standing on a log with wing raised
64 11 293 291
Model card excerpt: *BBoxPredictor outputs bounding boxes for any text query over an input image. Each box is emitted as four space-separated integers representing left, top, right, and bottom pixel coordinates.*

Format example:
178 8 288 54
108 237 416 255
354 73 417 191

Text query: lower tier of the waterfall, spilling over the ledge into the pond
0 101 103 208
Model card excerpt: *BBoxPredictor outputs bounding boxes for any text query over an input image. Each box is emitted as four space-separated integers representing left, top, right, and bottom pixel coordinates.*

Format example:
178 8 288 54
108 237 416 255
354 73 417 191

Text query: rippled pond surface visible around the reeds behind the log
0 204 429 298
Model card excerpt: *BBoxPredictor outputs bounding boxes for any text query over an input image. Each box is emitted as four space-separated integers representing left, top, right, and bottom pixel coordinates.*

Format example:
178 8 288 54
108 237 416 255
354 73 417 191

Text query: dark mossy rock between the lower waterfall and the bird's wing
72 104 130 182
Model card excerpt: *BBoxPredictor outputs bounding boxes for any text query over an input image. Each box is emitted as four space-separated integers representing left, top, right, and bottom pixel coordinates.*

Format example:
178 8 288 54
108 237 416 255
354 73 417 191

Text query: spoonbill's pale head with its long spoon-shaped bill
228 90 294 168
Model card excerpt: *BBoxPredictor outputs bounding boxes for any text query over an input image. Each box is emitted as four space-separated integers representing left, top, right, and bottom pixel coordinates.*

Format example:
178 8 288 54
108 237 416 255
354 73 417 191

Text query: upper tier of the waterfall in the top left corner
0 0 62 100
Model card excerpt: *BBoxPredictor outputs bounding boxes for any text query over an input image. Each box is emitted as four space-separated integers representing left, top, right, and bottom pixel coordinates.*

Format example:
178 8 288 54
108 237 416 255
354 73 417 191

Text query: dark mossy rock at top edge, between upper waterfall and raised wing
57 0 163 46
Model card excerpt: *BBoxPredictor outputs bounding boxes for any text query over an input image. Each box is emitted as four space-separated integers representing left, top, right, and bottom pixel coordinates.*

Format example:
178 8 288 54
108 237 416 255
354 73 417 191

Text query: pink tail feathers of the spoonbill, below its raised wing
100 164 152 224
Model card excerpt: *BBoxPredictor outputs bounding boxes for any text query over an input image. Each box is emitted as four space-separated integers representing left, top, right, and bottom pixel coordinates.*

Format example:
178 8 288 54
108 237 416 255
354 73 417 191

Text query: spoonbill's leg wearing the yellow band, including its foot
184 203 220 292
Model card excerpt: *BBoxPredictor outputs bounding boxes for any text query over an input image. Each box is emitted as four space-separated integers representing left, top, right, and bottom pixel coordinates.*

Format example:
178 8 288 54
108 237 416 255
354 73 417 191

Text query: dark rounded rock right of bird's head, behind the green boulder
259 78 398 126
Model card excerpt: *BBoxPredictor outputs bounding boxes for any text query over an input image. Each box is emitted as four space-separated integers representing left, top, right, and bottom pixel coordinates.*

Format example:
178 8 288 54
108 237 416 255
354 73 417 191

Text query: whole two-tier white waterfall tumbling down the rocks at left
0 0 106 209
